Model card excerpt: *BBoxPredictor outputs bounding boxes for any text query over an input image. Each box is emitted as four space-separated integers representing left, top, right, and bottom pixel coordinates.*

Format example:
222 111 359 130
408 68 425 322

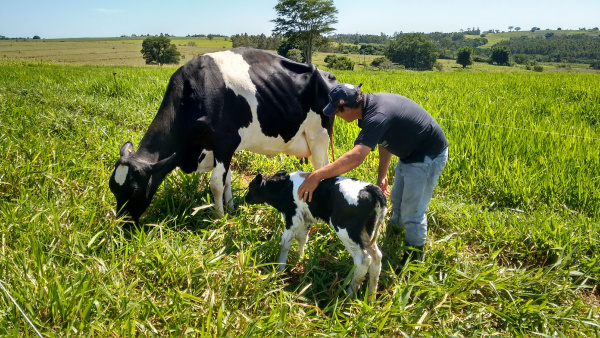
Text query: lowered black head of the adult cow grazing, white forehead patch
109 142 176 223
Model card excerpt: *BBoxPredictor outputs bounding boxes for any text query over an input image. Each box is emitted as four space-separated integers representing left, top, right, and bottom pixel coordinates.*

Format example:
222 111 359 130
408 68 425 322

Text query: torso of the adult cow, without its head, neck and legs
180 48 333 157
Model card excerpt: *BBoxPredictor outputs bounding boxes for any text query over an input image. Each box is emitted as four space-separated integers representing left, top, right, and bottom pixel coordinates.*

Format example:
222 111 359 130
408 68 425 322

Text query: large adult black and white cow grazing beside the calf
109 48 338 222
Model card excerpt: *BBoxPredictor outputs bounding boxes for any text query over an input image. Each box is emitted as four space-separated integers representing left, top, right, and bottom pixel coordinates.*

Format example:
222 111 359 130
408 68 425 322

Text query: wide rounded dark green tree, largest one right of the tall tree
385 33 438 70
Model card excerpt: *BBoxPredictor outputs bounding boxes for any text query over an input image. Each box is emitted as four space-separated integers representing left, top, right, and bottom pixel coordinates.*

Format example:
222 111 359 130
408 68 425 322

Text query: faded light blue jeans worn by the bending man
389 148 448 246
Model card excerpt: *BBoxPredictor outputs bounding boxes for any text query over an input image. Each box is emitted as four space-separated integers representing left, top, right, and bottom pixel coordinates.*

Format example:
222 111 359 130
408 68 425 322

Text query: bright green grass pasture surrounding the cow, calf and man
0 58 600 337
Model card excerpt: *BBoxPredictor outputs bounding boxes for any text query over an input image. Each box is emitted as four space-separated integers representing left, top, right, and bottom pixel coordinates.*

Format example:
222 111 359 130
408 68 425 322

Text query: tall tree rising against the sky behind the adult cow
271 0 337 64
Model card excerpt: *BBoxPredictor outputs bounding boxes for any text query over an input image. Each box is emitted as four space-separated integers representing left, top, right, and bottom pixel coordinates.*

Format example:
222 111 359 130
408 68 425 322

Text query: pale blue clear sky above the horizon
0 0 600 38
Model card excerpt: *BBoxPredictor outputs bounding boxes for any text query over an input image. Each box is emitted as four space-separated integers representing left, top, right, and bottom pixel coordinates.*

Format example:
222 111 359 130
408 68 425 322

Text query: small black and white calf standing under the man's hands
245 170 387 298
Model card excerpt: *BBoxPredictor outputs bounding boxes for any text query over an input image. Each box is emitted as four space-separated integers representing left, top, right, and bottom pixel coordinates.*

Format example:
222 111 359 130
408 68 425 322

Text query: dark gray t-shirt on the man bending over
354 93 448 163
